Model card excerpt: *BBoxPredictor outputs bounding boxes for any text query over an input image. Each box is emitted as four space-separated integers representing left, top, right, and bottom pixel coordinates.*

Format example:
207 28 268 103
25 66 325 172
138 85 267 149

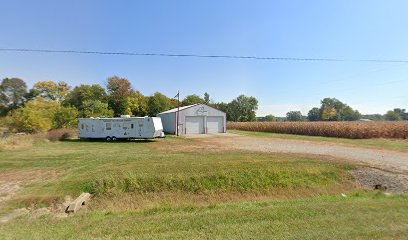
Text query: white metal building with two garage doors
157 104 227 135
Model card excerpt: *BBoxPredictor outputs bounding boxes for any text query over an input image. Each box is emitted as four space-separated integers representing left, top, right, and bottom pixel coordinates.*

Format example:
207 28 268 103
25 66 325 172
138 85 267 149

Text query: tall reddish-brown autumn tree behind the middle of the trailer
106 76 133 115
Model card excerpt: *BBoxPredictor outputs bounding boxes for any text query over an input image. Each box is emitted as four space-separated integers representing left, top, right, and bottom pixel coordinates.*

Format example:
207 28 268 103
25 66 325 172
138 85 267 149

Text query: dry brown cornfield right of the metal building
227 122 408 139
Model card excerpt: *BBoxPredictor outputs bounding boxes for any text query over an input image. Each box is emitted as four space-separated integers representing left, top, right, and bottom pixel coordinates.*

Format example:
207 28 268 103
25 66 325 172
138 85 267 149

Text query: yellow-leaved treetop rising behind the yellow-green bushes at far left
33 81 71 101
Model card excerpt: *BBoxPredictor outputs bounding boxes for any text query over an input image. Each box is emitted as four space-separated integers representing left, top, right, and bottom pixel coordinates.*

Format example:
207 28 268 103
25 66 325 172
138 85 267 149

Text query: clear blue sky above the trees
0 0 408 116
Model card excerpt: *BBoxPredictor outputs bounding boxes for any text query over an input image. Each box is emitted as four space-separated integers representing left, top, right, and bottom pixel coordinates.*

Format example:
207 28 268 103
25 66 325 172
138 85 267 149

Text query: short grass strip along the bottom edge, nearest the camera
0 194 408 239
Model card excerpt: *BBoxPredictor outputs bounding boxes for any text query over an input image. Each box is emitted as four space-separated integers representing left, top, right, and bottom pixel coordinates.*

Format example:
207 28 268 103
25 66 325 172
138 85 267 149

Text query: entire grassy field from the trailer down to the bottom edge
0 137 408 239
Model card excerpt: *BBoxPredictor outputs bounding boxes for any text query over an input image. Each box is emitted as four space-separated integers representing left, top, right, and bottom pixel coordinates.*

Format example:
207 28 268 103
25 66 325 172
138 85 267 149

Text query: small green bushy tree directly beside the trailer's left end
53 106 78 128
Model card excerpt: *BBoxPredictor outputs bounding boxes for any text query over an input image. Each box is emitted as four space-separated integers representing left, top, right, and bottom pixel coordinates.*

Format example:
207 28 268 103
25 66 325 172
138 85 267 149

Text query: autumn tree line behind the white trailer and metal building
0 76 258 132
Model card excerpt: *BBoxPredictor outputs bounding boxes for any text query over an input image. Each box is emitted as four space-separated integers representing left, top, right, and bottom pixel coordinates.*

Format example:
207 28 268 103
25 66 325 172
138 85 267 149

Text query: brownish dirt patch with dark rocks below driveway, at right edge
352 168 408 194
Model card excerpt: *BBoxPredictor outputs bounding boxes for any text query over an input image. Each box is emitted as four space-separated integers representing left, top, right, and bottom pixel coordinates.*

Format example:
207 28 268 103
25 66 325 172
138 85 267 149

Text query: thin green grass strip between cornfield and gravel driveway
228 130 408 151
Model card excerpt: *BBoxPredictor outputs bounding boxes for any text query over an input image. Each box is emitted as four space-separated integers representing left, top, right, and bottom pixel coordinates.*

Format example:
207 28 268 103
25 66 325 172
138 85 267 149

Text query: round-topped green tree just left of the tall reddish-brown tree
63 84 108 111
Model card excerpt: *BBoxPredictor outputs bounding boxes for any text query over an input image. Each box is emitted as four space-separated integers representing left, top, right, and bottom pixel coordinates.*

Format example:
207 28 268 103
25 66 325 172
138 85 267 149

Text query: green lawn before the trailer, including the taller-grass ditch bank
0 138 351 205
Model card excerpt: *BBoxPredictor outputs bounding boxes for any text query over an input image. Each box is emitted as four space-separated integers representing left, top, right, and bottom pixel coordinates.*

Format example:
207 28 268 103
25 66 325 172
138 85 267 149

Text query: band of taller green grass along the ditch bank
86 169 345 195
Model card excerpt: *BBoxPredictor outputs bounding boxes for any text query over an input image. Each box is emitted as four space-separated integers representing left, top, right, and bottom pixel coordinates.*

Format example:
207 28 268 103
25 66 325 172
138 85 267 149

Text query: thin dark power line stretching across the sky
0 48 408 63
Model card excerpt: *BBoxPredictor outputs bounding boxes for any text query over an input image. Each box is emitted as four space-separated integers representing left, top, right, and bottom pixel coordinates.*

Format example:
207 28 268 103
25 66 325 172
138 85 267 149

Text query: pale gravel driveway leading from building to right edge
211 136 408 193
